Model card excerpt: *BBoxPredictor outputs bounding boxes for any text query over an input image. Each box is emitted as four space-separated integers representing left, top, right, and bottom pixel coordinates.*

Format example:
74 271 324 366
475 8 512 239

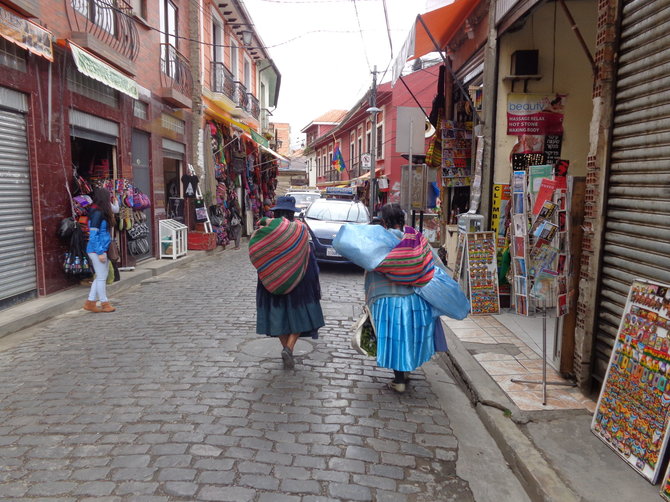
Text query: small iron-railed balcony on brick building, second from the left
160 44 193 108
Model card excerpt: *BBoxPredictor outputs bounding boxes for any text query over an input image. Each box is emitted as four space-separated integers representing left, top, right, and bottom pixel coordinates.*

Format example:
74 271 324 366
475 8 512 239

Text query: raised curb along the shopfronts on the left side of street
0 246 224 338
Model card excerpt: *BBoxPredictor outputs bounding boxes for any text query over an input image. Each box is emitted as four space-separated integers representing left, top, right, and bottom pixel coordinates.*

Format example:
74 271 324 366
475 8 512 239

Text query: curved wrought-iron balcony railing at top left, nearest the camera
65 0 140 61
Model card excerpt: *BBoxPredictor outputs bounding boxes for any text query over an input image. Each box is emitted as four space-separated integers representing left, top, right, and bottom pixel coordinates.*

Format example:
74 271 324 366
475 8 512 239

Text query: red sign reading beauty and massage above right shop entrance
507 94 565 136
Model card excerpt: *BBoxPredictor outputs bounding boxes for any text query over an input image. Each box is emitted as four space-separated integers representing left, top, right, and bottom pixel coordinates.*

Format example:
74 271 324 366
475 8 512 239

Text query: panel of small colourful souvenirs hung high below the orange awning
441 120 472 187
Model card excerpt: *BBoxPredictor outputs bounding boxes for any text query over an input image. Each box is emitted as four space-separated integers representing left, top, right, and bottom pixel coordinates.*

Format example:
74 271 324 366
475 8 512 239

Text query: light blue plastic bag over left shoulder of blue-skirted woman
333 223 400 271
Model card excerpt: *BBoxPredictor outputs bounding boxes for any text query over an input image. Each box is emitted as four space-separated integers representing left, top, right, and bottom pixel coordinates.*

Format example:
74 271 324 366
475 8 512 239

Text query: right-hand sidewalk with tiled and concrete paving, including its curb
441 316 661 502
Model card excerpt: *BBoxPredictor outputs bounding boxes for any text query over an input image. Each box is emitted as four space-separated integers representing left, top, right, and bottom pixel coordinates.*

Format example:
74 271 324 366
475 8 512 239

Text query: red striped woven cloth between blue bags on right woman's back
375 227 435 287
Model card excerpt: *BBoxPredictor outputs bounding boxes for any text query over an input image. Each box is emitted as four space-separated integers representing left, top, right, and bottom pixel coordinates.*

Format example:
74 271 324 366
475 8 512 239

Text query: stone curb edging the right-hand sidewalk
440 322 581 502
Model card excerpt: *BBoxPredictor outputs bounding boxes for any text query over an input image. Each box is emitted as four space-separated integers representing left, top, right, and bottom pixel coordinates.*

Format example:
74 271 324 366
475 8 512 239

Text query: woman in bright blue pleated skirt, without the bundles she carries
365 203 435 392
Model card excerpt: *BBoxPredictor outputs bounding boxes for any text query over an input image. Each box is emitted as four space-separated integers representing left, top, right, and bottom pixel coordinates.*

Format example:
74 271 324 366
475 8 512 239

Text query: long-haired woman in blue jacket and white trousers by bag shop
84 187 116 312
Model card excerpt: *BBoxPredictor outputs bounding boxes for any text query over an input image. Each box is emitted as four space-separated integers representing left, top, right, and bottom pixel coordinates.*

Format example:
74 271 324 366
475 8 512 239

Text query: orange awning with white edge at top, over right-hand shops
392 0 479 84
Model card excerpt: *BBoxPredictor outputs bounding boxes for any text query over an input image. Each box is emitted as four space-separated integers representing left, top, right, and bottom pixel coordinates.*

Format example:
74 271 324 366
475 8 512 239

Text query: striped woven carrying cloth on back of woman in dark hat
249 218 309 295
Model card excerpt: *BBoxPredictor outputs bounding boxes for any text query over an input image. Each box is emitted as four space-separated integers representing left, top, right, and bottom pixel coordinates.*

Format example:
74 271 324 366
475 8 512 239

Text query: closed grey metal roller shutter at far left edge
0 110 37 301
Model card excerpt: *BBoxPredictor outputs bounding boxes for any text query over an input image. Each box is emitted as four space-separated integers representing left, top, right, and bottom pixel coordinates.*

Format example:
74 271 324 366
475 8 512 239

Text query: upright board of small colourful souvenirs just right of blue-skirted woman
466 232 500 315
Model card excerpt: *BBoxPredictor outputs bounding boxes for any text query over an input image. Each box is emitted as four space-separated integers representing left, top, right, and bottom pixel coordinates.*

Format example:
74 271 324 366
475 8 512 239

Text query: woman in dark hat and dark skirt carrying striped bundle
249 196 325 369
